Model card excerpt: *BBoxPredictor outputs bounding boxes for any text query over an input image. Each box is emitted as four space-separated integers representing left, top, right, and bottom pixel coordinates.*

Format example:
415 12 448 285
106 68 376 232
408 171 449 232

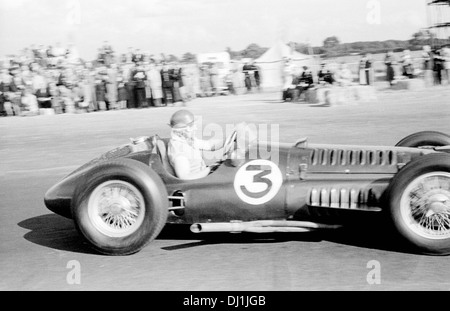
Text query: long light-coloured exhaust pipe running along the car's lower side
191 220 340 233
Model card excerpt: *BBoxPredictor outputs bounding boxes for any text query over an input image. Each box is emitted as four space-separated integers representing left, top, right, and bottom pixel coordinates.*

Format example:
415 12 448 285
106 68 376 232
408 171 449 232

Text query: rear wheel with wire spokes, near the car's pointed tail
72 159 168 256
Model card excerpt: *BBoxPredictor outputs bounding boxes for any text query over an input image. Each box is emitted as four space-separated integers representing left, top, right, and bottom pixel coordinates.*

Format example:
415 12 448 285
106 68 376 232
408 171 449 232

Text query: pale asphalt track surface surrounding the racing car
0 87 450 291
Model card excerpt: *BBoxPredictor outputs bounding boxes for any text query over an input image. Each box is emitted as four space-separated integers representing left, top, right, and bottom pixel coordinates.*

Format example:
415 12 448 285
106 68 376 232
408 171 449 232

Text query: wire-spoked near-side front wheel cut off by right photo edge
386 153 450 255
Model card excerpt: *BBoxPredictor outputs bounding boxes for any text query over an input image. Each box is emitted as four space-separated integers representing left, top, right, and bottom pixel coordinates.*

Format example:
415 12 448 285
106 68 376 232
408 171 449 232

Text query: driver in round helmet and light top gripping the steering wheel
168 110 232 180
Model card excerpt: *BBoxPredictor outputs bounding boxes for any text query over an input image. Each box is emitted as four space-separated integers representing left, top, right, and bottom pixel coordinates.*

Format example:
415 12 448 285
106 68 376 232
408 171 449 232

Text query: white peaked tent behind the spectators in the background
254 42 316 90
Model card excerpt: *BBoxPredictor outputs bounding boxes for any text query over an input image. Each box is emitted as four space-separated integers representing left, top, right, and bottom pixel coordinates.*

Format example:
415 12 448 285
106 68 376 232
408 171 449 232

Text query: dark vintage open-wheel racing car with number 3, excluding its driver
45 130 450 255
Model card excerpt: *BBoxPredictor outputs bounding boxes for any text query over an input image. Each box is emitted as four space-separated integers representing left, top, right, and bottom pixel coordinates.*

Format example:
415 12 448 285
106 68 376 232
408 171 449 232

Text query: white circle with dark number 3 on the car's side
234 160 283 205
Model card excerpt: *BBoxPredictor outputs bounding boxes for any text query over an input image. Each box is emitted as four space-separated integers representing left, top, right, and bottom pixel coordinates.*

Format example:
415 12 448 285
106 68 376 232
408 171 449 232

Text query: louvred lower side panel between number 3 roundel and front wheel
286 148 397 217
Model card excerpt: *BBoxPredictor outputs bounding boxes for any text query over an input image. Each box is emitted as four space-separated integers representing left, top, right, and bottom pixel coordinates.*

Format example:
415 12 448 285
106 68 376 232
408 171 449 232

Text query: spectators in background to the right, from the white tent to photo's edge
283 46 450 101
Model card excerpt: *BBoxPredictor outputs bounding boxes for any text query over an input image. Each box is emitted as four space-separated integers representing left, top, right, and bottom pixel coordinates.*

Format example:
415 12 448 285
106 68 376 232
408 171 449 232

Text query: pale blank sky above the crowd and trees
0 0 436 59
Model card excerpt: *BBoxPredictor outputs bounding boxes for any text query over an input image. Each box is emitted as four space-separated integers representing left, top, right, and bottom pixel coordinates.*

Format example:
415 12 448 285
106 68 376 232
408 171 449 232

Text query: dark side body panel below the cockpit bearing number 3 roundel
163 146 288 223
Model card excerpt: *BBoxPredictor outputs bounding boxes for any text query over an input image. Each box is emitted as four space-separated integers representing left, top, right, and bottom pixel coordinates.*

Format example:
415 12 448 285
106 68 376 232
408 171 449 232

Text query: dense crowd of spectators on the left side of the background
0 41 253 116
